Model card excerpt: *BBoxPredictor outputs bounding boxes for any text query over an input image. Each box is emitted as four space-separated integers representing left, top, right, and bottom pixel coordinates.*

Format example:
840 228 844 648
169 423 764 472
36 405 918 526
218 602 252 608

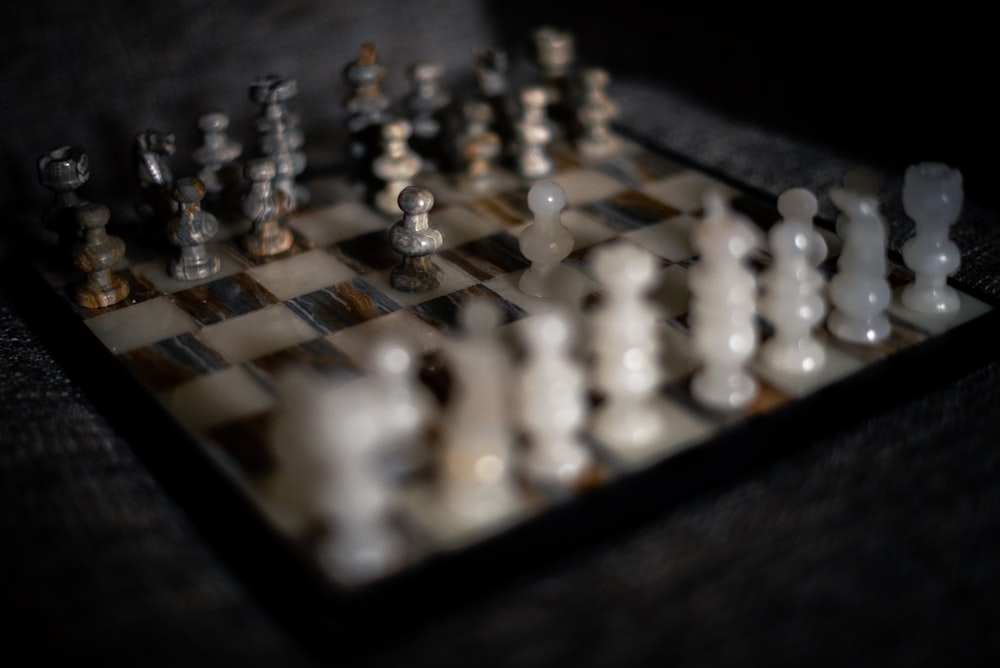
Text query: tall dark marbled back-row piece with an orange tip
342 42 389 185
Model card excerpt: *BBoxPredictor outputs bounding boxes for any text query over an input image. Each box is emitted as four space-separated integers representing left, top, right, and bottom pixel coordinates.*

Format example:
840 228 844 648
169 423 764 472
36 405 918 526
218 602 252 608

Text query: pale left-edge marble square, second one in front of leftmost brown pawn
157 366 275 431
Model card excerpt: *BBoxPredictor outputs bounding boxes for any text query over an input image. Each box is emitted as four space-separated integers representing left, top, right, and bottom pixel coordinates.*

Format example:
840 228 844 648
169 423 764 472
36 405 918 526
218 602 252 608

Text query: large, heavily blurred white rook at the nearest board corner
272 373 404 581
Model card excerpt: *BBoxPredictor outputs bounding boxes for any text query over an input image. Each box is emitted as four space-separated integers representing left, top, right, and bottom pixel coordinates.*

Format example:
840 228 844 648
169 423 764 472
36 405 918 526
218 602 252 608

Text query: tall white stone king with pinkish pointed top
690 191 758 410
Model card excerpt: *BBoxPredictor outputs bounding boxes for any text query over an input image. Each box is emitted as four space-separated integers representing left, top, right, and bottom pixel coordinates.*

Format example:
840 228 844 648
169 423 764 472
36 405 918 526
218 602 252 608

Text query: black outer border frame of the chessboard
7 128 1000 658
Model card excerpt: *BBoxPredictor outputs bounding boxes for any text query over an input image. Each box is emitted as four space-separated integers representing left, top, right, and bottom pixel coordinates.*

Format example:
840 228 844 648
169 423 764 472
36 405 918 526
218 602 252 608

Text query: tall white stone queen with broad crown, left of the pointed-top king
590 242 667 449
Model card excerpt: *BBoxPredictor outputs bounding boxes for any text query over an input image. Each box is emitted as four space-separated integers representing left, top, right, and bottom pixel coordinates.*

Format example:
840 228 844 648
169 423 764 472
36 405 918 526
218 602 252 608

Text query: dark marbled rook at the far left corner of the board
37 146 90 266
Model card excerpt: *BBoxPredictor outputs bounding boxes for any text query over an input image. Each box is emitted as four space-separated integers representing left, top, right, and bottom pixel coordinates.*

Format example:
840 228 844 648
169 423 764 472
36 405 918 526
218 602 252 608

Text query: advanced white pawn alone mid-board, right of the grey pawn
518 181 573 297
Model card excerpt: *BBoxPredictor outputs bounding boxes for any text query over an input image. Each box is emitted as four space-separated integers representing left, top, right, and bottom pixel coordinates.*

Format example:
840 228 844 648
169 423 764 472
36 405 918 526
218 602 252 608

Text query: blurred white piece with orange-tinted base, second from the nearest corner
439 300 517 527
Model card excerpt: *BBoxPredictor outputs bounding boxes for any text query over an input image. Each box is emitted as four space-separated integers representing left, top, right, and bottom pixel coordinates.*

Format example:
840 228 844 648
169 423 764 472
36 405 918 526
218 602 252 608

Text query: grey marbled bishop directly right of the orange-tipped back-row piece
404 61 451 169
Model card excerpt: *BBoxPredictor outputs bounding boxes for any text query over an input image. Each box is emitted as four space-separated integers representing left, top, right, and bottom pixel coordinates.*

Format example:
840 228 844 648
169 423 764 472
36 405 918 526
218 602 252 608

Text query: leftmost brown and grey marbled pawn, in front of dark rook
73 202 129 308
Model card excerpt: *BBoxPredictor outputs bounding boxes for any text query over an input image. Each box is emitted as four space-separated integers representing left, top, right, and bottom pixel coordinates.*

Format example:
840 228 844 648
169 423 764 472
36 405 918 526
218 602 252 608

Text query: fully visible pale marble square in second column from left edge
195 304 320 364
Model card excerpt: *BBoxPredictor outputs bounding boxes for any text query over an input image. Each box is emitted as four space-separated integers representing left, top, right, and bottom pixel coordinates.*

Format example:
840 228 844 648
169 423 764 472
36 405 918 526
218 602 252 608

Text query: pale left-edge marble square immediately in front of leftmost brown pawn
84 297 198 353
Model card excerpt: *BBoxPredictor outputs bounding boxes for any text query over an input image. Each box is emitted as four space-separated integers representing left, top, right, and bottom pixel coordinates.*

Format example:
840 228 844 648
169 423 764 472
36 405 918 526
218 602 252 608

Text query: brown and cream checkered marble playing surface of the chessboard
15 129 995 628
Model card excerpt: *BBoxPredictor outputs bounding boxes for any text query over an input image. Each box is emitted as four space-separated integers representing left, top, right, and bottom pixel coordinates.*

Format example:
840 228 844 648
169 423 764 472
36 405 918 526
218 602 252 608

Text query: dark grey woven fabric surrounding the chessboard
0 0 1000 666
